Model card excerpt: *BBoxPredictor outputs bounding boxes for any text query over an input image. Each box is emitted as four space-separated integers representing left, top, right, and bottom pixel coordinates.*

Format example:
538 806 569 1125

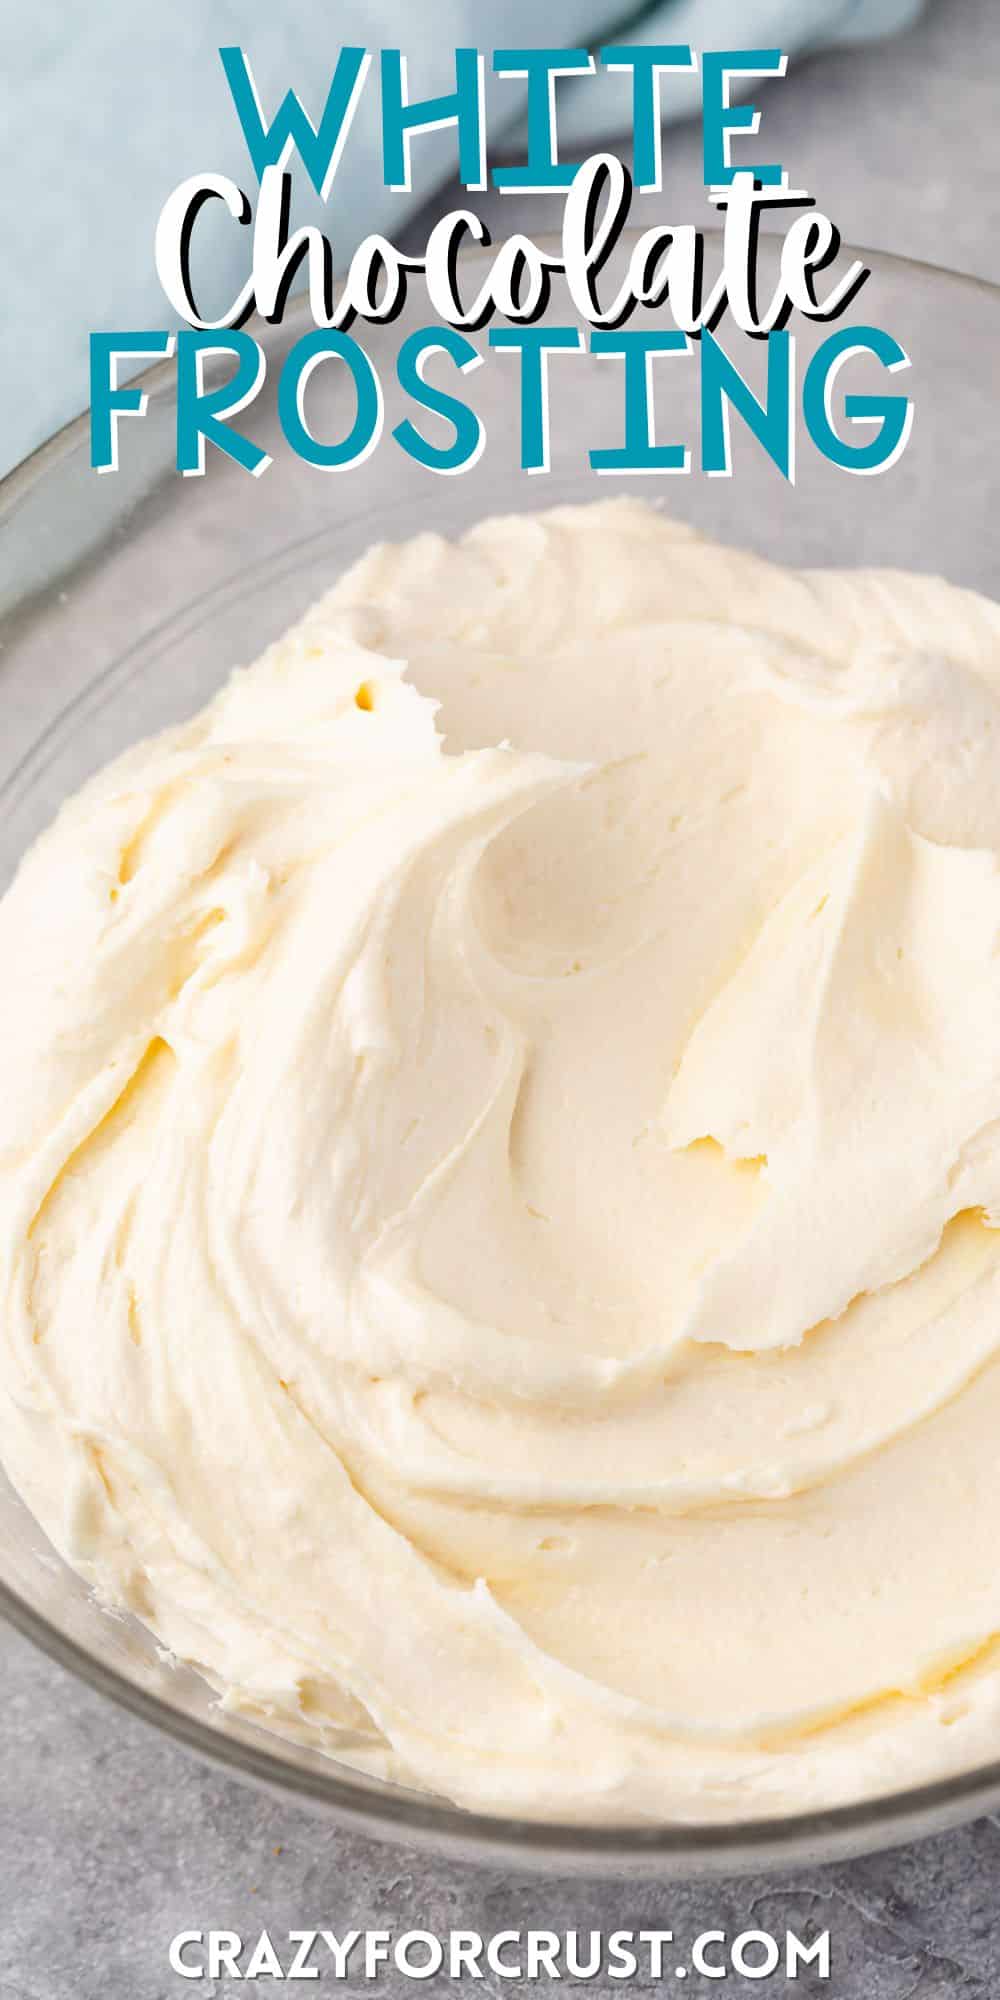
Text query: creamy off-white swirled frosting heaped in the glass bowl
0 502 1000 1822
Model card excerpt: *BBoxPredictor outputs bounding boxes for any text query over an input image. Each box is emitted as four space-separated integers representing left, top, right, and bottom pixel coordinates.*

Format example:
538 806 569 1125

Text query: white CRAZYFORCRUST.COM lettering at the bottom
168 1930 830 1980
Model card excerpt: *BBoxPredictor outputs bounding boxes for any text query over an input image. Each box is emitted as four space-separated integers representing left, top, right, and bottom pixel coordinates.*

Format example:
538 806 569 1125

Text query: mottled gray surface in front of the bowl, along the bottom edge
0 1638 1000 2000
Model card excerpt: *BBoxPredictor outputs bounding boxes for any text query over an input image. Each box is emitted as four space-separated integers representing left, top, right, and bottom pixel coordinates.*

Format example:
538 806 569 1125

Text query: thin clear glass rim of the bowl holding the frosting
0 228 1000 1876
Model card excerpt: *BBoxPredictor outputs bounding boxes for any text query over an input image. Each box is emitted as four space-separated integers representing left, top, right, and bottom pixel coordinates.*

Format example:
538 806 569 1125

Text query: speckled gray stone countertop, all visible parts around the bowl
0 0 1000 2000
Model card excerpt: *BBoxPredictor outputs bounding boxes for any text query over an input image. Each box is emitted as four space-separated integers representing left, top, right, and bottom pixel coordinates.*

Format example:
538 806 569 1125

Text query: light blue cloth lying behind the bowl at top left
0 0 924 470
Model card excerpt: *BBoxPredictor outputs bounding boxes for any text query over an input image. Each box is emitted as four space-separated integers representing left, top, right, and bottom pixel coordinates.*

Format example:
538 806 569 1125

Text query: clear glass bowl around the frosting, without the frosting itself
0 236 1000 1874
